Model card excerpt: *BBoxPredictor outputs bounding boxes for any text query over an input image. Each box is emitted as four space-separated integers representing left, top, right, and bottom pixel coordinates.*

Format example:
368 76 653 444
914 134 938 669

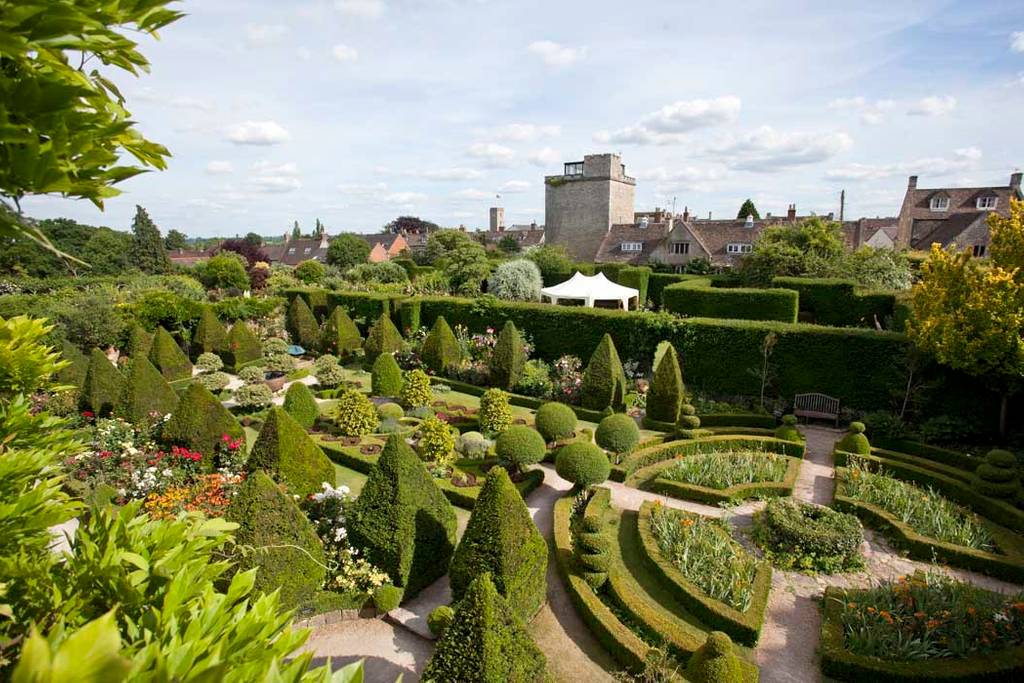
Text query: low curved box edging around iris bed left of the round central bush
637 501 771 647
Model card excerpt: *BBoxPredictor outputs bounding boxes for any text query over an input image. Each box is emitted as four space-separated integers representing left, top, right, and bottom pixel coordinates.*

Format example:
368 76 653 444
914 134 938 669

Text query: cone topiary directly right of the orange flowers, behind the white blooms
246 405 335 498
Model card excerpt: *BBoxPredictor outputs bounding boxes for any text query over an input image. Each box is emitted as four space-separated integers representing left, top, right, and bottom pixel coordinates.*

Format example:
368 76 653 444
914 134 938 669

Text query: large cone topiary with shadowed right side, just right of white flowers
348 434 456 598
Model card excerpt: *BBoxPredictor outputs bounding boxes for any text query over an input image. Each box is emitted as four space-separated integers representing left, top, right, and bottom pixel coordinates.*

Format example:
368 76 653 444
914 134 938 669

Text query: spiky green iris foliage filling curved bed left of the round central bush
650 503 757 611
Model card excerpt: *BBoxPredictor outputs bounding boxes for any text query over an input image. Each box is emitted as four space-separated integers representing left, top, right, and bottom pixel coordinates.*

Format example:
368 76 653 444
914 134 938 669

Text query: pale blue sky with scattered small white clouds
23 0 1024 237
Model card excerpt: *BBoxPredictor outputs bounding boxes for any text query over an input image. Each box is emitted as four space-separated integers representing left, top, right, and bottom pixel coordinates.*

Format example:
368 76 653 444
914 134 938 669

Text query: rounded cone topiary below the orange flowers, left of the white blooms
224 471 327 609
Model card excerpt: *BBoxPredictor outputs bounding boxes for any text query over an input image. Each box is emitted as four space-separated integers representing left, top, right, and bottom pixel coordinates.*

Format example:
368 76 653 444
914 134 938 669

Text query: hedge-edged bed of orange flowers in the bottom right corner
820 572 1024 681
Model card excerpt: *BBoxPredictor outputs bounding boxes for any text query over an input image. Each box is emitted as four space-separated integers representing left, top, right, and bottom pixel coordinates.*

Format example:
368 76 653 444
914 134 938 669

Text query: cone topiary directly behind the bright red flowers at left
161 382 246 470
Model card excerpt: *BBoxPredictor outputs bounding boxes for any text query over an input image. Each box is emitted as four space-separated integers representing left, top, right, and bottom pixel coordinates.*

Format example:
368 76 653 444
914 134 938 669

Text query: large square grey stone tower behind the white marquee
544 154 637 261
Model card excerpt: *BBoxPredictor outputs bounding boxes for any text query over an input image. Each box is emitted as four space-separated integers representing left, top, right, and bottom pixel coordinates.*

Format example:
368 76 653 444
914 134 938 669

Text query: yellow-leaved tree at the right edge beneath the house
907 201 1024 434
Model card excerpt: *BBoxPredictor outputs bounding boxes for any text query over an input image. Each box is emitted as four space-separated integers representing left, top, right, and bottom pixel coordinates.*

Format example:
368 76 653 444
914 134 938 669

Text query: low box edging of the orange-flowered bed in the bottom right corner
818 586 1024 683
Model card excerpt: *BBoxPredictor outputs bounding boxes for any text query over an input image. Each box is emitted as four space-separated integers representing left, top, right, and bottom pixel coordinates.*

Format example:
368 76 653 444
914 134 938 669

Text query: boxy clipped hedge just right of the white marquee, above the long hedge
662 278 800 323
